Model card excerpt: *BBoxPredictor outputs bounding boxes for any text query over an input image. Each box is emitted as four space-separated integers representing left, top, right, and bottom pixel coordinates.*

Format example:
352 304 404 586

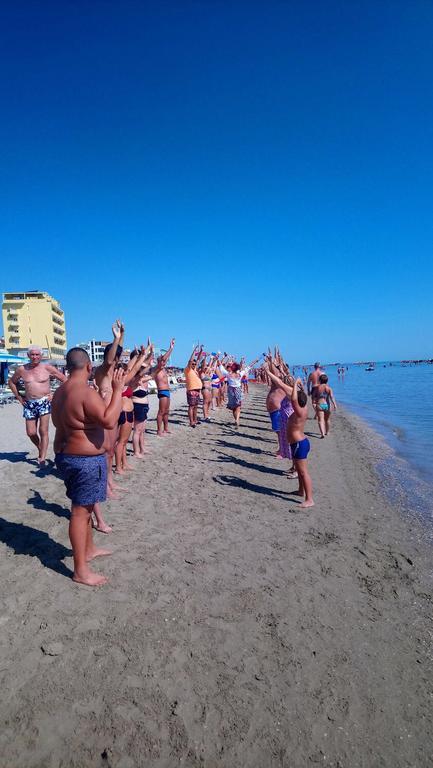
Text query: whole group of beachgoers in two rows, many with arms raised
10 320 336 586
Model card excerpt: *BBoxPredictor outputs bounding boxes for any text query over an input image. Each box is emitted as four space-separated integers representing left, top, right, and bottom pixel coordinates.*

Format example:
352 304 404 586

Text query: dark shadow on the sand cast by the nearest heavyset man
0 517 72 578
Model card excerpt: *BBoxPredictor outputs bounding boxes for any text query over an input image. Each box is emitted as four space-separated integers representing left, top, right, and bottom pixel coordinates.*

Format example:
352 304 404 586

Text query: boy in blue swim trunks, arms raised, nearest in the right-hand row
287 379 314 509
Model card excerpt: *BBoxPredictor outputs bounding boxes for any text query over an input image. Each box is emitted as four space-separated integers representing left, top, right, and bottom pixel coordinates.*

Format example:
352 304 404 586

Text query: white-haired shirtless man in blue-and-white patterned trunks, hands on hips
9 346 66 467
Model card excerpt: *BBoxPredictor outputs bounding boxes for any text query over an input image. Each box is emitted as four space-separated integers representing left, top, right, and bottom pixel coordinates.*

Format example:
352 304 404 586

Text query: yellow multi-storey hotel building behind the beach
2 291 66 360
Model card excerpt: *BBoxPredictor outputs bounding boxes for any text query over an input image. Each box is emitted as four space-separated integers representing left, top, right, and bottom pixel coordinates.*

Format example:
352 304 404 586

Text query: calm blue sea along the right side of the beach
296 361 433 523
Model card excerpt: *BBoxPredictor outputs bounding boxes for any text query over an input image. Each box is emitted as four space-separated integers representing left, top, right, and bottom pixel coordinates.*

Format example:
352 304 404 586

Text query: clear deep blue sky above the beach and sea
0 0 433 363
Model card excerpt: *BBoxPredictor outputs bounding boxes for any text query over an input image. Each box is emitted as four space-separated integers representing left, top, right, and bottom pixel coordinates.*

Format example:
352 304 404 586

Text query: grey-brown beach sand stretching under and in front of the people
0 386 433 768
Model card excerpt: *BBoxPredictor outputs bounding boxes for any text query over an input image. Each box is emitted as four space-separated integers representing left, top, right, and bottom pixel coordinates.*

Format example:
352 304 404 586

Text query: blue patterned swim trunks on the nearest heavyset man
56 453 107 507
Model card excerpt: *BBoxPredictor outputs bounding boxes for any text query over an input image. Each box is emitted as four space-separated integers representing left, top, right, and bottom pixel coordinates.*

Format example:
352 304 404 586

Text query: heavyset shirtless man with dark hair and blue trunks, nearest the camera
52 347 125 587
